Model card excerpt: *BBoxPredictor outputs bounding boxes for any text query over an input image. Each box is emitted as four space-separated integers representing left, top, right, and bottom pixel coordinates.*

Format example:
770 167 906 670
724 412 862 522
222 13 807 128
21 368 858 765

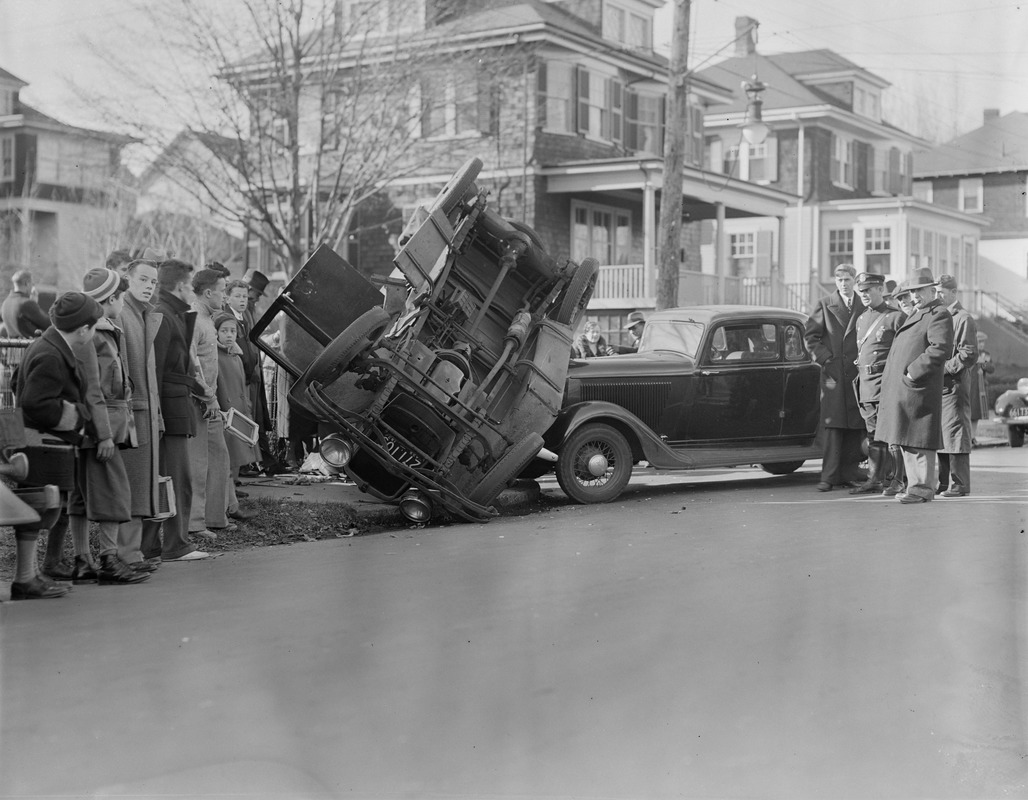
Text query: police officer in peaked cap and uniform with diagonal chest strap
849 272 906 495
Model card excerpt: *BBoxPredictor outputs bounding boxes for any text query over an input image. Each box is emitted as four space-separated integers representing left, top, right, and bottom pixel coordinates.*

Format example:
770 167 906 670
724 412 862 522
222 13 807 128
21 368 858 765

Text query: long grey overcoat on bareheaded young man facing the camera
118 293 163 517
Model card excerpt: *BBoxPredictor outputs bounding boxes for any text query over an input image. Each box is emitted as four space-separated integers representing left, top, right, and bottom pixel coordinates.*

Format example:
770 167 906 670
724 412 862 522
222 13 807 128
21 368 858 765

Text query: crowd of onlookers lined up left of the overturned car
0 251 279 599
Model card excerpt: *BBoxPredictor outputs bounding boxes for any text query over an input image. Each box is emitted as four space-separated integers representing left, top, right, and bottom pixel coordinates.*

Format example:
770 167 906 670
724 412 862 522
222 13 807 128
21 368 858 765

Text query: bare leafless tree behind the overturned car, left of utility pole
81 0 518 271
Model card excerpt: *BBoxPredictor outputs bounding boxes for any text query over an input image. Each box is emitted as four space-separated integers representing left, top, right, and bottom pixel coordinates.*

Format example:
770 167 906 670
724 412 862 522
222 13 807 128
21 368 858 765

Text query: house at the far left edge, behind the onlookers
0 69 132 293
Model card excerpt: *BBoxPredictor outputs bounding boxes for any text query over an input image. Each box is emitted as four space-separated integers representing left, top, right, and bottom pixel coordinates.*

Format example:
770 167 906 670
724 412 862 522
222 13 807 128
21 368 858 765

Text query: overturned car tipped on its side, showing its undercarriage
252 158 598 521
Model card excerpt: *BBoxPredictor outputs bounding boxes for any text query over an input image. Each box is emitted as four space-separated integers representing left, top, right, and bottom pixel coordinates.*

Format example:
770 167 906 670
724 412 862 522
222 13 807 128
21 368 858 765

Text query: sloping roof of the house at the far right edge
914 111 1028 177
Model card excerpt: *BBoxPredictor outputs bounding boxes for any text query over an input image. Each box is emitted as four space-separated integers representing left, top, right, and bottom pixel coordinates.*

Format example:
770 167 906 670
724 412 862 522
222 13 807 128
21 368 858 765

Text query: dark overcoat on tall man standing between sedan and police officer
804 292 865 430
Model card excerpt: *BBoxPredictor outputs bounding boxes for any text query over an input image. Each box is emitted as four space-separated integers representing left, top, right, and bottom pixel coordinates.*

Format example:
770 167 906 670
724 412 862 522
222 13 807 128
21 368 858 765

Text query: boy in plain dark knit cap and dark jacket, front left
10 292 103 599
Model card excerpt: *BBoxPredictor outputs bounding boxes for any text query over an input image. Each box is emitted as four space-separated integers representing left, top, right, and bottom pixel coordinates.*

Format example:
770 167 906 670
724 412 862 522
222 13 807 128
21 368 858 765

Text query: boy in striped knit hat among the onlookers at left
68 267 150 584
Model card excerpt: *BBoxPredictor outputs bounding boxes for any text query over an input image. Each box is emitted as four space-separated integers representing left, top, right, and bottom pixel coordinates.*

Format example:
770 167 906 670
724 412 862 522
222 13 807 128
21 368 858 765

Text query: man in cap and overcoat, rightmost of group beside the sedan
935 275 978 498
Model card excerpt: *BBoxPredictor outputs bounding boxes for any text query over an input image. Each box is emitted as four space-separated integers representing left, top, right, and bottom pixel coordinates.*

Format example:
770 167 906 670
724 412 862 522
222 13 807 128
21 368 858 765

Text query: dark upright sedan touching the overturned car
525 305 821 503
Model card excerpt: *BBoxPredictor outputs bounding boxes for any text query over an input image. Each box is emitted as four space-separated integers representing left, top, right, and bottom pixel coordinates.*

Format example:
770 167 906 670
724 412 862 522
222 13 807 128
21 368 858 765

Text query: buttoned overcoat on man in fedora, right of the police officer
876 300 953 450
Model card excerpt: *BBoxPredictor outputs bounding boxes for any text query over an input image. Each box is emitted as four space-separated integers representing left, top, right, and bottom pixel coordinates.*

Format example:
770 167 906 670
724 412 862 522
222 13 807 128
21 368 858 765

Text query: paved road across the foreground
0 448 1028 798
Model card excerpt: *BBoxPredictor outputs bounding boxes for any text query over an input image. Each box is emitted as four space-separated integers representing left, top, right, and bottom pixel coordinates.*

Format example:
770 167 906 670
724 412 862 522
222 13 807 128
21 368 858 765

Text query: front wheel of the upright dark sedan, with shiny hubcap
557 424 632 503
